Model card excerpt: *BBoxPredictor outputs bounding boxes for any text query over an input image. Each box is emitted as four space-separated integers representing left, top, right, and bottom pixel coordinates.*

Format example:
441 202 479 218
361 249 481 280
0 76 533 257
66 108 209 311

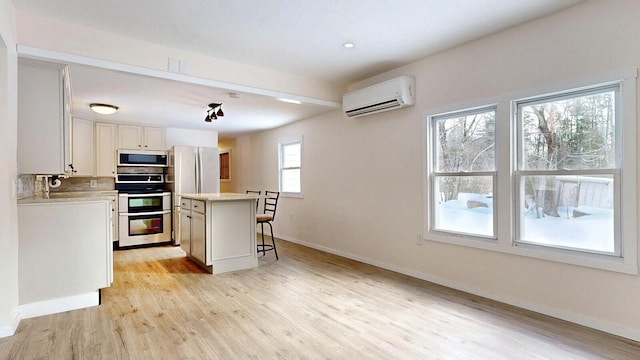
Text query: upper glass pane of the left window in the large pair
434 110 496 172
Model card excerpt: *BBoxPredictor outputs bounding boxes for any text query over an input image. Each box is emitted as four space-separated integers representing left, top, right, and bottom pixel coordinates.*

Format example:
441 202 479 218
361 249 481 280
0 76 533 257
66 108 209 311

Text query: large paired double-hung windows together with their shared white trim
423 69 638 274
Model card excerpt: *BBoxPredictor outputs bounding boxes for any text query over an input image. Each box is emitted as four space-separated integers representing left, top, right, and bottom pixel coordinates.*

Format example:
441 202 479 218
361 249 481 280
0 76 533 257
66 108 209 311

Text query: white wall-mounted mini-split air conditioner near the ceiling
342 76 415 117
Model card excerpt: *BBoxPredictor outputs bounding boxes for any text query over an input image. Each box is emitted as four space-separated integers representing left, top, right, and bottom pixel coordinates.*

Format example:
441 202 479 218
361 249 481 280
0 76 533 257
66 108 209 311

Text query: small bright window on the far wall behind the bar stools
278 138 302 196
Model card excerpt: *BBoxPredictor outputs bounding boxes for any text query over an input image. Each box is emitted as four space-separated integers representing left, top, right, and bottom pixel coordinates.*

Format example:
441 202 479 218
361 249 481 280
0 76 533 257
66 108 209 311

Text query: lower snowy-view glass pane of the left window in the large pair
434 176 494 237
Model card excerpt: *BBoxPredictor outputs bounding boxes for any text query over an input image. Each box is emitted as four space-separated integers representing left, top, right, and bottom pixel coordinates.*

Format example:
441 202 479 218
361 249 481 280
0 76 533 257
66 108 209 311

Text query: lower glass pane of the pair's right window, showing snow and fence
520 175 615 253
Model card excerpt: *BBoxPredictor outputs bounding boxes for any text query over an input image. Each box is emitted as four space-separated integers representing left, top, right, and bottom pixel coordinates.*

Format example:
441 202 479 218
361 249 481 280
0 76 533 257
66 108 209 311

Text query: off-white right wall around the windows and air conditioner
234 0 640 340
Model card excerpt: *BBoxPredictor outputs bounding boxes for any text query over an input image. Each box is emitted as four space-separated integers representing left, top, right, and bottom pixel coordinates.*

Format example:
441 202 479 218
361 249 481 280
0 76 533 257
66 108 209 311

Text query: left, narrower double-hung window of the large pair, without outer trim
430 107 496 238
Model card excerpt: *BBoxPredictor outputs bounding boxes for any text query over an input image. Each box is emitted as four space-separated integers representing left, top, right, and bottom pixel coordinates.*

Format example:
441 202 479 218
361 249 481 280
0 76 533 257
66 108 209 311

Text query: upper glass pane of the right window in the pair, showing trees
520 90 616 170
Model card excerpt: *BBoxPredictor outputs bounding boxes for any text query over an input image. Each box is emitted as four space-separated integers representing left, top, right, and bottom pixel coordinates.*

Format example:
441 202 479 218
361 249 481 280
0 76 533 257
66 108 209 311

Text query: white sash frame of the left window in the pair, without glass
427 104 498 241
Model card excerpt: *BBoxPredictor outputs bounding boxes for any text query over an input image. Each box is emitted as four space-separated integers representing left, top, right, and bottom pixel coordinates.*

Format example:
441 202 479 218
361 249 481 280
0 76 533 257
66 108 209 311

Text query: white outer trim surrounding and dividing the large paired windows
422 68 638 275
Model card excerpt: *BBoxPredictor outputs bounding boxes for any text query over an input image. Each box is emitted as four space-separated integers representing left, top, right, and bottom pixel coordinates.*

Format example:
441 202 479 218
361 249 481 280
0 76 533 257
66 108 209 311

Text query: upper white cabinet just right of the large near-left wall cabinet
71 117 94 176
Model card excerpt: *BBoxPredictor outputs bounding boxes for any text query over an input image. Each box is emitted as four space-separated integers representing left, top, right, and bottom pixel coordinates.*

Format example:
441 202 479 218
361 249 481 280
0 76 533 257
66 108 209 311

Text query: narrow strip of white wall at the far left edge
0 0 19 337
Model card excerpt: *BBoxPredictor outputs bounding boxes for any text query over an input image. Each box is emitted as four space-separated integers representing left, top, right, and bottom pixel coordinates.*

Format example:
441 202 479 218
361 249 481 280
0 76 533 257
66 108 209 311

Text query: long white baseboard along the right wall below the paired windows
275 235 640 341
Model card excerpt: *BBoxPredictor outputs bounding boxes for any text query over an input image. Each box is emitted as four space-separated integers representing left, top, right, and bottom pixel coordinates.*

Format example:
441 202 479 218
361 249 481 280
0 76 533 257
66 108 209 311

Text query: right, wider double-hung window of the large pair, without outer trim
515 84 621 255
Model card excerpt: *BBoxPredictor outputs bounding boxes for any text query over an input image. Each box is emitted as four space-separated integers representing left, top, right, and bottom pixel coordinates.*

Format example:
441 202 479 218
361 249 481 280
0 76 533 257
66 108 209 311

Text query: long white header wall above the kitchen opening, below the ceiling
16 12 342 101
